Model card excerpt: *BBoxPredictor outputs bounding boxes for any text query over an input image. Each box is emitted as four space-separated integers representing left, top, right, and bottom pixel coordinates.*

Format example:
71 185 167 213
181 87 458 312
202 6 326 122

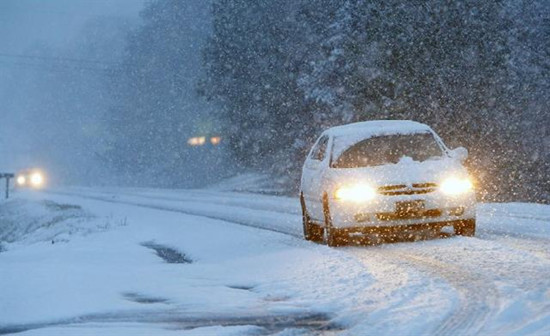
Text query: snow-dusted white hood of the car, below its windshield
326 158 468 187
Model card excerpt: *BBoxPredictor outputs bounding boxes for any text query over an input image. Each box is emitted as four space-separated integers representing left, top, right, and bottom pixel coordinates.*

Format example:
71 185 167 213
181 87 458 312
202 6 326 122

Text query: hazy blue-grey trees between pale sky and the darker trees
108 0 221 186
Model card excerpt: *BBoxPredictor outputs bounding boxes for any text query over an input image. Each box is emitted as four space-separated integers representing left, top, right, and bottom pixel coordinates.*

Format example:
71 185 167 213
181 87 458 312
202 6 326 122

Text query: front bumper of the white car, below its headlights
329 191 476 228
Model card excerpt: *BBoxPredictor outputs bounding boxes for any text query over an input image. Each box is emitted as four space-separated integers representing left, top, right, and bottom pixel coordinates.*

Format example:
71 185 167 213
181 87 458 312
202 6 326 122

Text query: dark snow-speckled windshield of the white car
332 133 443 168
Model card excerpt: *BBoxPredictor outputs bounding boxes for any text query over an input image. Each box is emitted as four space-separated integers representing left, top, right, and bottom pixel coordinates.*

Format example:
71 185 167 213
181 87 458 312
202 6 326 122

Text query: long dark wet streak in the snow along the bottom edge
0 311 344 335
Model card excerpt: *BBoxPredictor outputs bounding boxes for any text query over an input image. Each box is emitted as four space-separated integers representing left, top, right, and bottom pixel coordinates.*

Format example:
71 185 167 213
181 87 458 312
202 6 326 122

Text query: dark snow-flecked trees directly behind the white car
203 0 549 199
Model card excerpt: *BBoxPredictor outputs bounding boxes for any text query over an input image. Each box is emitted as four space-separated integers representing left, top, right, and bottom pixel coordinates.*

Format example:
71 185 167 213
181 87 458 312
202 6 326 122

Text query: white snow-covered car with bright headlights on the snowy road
300 120 476 246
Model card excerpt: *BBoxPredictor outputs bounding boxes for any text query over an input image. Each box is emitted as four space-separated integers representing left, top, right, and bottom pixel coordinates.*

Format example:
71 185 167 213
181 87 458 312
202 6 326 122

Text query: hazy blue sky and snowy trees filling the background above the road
0 0 550 202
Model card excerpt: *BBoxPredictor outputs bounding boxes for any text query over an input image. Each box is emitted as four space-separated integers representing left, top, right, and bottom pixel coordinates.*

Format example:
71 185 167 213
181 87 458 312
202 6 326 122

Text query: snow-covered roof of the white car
323 120 432 137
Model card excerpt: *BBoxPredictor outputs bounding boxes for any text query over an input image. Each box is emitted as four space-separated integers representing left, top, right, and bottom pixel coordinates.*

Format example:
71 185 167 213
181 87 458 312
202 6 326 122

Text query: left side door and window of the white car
302 135 329 221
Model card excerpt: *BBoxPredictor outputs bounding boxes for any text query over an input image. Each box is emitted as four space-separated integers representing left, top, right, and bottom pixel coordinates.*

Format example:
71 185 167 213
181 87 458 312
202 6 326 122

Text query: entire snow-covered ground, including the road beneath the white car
0 188 550 335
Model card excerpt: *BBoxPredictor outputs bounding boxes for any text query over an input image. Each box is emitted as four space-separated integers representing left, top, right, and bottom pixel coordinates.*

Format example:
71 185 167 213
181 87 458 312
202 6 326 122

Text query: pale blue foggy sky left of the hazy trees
0 0 144 181
